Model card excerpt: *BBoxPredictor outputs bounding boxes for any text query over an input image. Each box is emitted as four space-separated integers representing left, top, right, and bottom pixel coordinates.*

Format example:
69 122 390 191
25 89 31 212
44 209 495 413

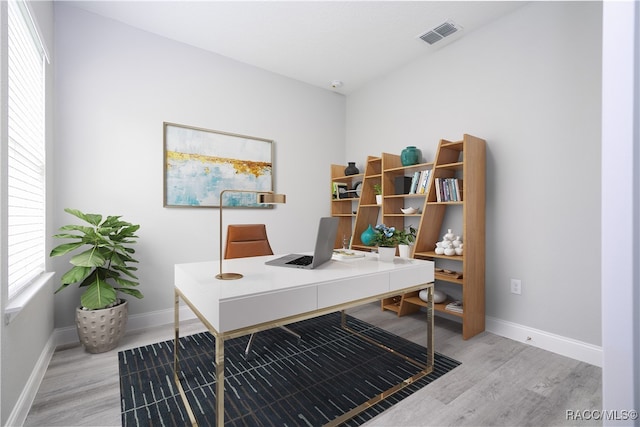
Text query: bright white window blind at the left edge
7 0 47 298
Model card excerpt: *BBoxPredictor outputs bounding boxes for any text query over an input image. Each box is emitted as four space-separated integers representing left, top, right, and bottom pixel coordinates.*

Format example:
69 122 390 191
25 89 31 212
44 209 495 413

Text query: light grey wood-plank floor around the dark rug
25 304 602 426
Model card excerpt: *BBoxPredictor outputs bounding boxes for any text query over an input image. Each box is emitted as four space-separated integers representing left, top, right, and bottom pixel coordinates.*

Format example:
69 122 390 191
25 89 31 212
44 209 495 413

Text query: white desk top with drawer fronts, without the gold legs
175 254 434 333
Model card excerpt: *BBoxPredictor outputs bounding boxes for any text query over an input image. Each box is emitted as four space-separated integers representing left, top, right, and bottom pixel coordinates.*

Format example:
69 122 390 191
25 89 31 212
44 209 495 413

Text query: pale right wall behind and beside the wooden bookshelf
347 2 600 346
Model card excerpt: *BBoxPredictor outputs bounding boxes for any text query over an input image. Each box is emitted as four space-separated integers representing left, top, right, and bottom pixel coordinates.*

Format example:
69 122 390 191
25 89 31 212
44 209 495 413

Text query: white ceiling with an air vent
69 0 526 94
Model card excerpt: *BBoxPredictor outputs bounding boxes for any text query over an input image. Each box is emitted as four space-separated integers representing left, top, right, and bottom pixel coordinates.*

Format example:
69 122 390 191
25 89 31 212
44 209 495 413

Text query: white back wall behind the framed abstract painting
53 4 345 328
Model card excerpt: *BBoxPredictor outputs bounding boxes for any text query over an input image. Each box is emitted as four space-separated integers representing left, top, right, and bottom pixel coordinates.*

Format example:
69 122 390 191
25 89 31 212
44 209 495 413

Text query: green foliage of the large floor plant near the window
49 208 143 310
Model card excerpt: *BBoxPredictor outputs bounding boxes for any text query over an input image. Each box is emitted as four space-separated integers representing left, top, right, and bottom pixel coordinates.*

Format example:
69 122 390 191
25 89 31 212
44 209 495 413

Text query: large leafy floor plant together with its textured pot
50 208 143 353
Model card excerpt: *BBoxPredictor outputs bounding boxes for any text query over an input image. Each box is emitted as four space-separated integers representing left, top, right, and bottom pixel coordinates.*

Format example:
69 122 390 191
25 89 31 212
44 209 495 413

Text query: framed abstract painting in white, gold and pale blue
164 123 273 208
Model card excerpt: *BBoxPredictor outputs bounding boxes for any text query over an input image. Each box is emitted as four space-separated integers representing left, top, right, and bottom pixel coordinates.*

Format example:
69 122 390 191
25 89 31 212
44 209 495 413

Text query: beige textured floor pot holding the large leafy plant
76 300 129 353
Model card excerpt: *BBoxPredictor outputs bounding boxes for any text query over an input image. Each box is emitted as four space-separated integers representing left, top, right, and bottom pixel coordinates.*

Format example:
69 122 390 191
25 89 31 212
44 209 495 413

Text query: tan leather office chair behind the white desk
224 224 301 357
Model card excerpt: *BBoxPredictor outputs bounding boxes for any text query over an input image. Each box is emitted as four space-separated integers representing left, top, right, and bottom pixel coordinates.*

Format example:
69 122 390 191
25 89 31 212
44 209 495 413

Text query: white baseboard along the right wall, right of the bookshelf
485 316 602 367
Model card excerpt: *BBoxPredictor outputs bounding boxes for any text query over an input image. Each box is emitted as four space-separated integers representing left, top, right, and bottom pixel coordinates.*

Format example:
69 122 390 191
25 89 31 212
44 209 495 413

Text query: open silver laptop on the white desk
265 217 338 270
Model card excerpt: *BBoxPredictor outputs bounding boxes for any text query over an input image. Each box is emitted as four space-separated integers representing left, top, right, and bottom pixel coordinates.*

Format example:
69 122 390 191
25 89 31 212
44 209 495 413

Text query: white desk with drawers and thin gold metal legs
174 254 434 426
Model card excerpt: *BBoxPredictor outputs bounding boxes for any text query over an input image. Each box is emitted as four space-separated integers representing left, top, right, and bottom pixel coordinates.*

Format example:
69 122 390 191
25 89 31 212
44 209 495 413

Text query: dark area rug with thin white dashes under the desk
118 313 460 426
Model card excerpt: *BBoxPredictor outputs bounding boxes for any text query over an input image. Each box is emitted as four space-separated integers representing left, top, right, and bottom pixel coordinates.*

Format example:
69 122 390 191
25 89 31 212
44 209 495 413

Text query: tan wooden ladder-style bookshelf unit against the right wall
332 134 486 339
